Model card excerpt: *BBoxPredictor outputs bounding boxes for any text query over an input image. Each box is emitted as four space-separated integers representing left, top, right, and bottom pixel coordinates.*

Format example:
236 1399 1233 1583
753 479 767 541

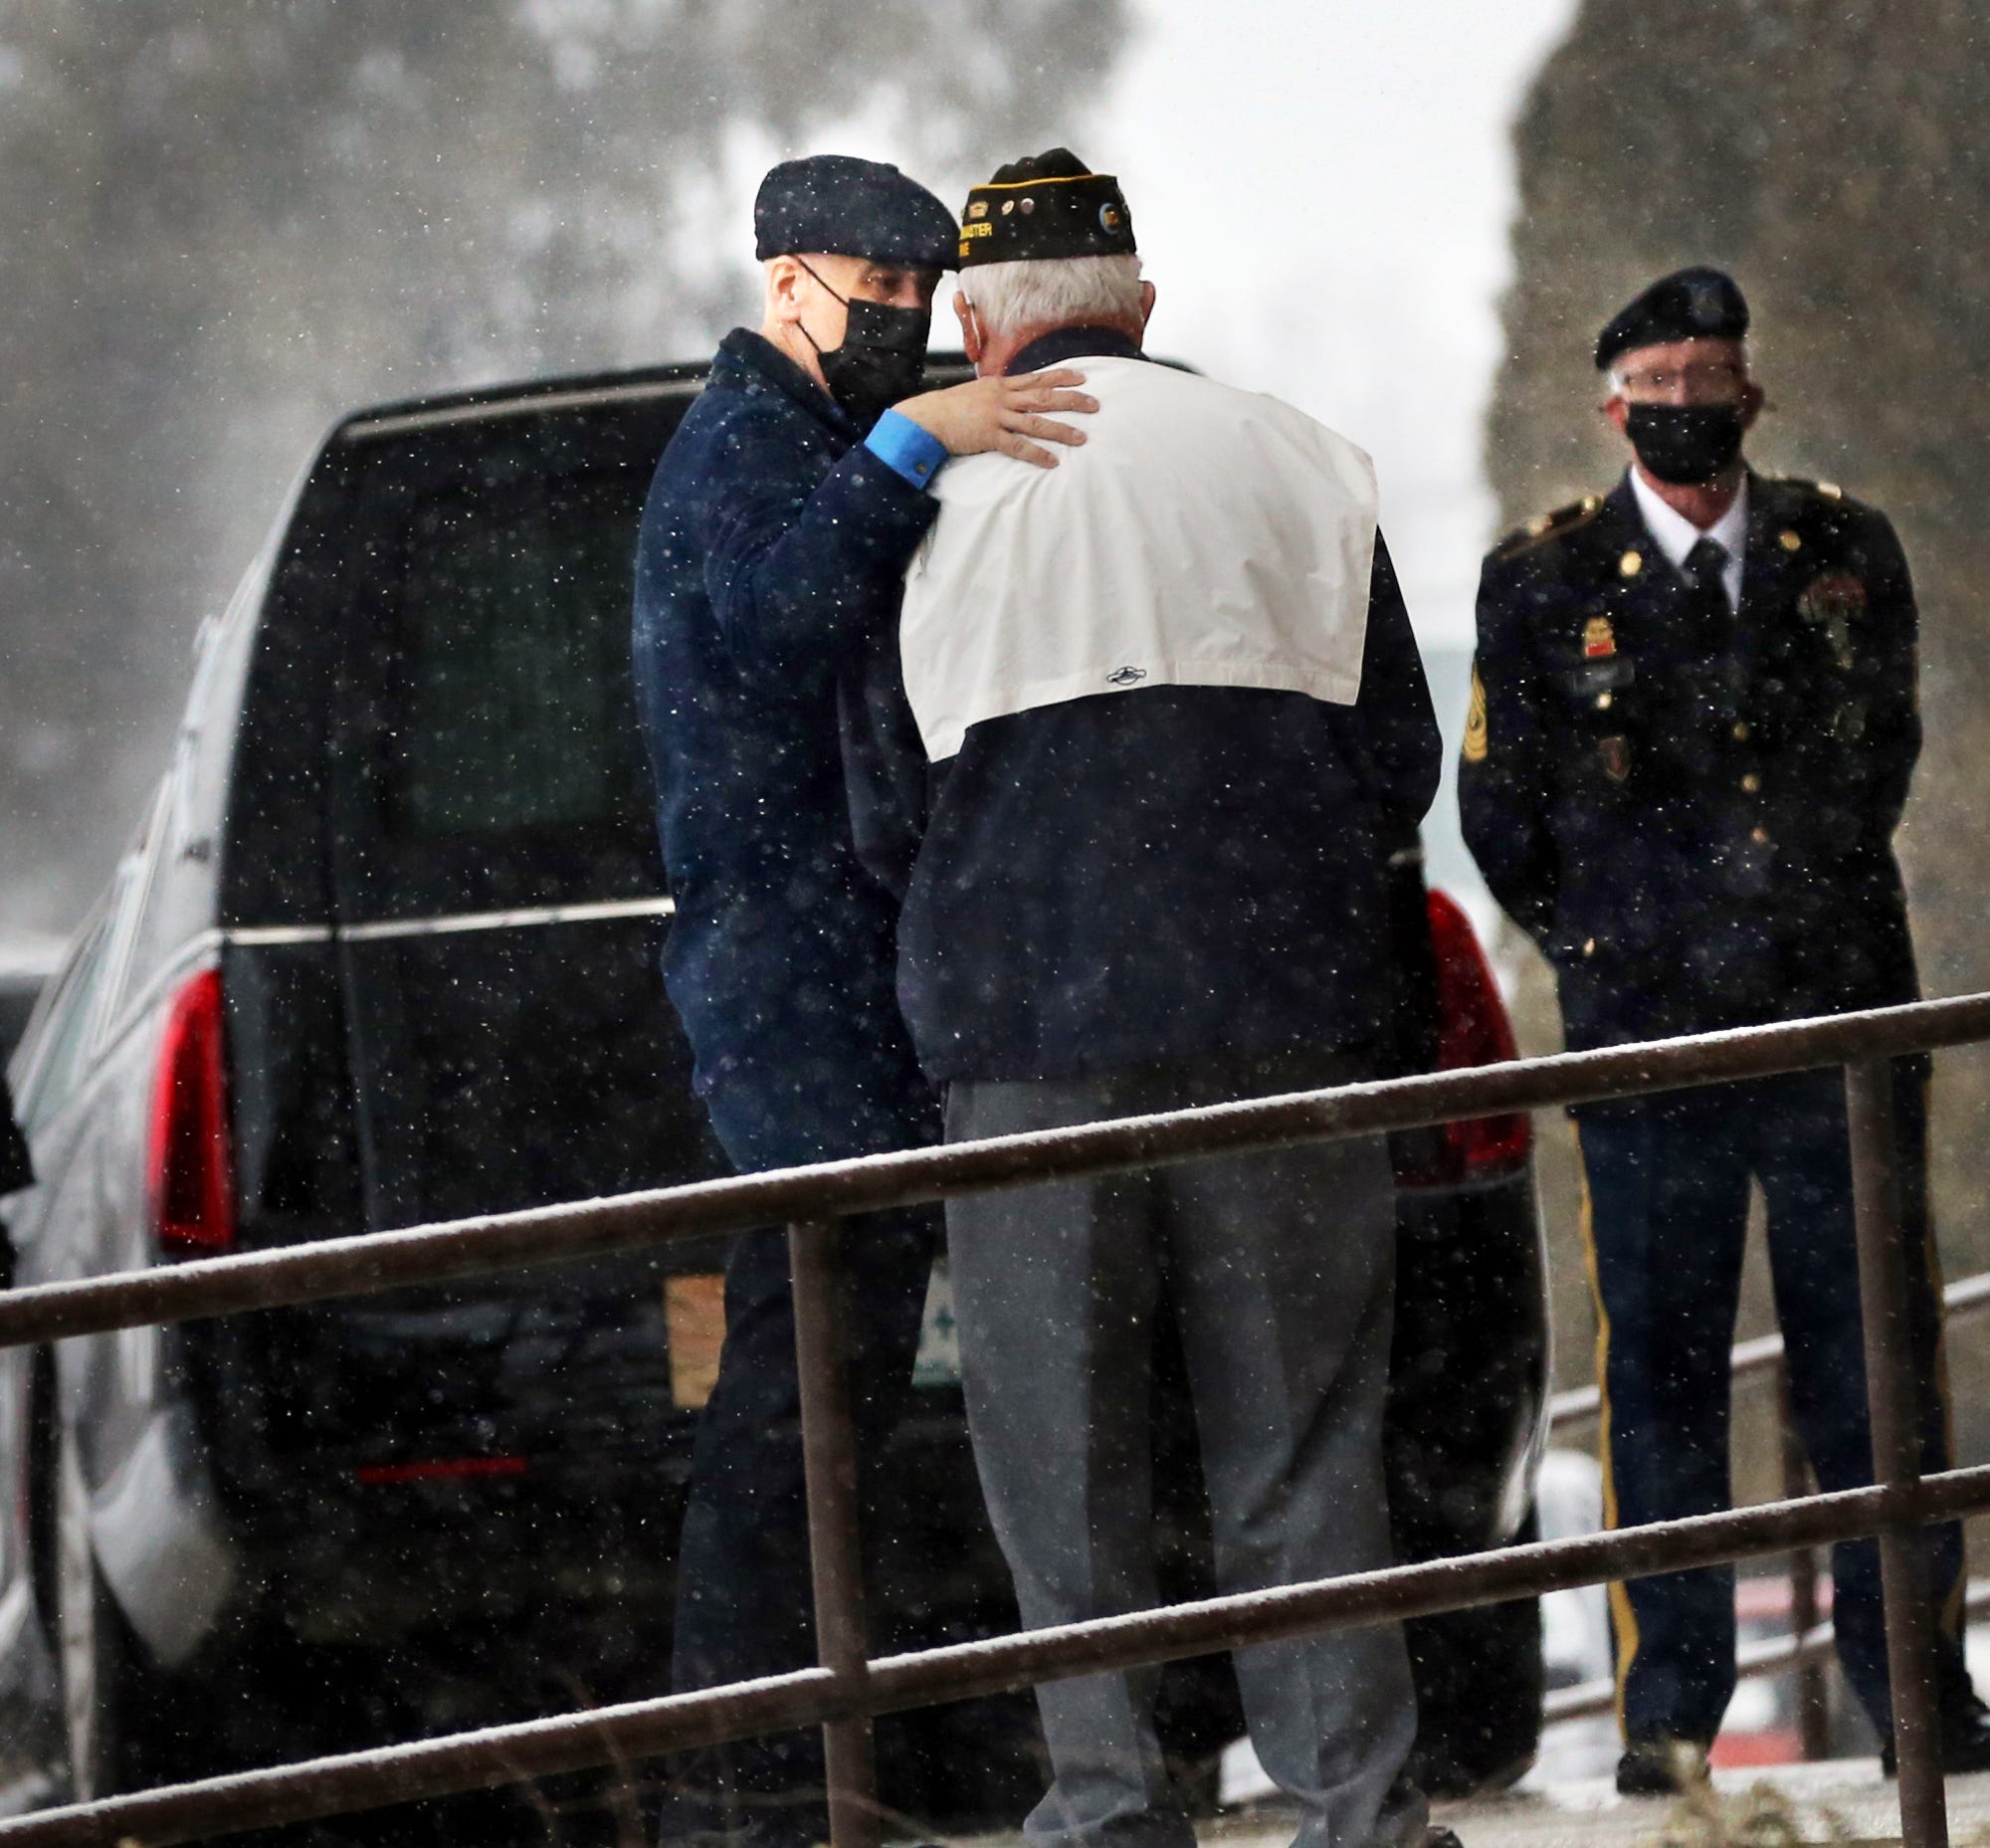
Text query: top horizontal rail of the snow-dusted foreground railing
0 994 1990 1346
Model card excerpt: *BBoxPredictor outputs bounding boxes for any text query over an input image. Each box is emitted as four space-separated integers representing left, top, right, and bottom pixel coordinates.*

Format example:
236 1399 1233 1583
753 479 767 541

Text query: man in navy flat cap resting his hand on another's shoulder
633 155 1093 1848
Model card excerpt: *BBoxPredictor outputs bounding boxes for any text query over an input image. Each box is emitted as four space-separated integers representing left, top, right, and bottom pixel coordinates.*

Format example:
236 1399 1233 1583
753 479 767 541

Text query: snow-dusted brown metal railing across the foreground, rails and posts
0 994 1990 1848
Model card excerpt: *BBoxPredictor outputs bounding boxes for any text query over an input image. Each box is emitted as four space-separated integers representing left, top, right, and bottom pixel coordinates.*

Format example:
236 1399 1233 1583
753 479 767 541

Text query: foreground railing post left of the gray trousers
788 1219 880 1848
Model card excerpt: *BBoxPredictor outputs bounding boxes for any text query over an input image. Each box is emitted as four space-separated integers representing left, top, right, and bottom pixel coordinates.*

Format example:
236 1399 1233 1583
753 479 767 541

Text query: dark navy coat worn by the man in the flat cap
635 328 935 1167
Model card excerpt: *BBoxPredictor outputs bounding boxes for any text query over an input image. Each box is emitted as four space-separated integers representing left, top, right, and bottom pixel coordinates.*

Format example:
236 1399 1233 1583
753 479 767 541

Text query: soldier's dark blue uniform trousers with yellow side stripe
1576 1060 1968 1745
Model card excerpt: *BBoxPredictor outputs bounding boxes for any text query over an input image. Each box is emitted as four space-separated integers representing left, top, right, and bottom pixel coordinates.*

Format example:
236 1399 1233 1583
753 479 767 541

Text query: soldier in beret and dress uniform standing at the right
1459 269 1990 1794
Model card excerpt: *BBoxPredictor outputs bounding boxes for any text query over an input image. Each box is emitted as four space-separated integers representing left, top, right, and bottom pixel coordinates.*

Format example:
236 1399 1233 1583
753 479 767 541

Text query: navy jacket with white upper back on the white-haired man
850 328 1439 1080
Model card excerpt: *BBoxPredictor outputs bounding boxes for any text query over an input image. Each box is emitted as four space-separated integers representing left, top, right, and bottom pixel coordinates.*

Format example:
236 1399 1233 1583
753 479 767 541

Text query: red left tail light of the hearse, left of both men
149 970 235 1257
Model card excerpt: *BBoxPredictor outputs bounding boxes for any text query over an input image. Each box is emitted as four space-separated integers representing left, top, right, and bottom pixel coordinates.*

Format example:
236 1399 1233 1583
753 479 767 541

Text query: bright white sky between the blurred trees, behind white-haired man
1077 0 1576 649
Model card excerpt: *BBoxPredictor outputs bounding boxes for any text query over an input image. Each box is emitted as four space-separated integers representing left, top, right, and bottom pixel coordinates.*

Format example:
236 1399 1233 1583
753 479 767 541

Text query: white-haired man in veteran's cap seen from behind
856 149 1439 1848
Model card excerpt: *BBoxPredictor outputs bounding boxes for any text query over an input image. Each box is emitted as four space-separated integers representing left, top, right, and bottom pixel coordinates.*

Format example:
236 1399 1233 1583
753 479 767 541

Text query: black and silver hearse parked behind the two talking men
0 366 1546 1822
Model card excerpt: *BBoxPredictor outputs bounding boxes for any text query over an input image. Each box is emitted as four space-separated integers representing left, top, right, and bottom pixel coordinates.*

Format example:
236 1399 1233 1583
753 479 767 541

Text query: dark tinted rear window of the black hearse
332 442 663 920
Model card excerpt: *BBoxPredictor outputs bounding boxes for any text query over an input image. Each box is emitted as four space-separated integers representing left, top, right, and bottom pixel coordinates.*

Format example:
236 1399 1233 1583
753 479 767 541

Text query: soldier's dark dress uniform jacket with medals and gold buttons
1459 474 1920 1048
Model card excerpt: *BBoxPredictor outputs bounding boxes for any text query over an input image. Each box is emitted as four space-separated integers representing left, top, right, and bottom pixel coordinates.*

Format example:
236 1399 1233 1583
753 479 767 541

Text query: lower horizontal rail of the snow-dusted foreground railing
11 1466 1990 1848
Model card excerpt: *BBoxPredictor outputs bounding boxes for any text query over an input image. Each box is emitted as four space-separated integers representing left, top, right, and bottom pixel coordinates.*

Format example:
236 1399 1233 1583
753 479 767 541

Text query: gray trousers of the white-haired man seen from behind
947 1058 1425 1848
